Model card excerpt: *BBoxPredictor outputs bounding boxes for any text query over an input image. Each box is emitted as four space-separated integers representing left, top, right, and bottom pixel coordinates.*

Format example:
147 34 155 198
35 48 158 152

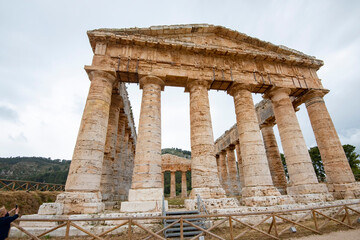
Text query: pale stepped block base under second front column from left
120 188 168 213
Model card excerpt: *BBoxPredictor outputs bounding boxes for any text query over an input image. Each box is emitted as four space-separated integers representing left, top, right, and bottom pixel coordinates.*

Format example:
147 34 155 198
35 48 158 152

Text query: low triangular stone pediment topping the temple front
88 24 323 66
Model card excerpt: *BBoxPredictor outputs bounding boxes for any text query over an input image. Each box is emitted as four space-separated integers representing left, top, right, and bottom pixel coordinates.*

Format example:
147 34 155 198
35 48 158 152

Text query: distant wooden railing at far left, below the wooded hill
0 179 65 191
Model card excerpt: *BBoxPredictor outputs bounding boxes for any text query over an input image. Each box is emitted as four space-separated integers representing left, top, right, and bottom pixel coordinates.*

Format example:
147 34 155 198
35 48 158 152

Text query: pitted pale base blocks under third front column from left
185 198 240 211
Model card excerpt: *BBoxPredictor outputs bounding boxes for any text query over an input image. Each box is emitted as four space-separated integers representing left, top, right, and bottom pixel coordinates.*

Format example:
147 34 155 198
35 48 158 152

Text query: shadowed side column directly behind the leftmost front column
100 91 122 201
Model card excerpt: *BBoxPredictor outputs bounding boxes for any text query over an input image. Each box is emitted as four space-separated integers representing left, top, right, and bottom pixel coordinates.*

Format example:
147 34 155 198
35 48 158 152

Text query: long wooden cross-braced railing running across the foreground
12 202 360 240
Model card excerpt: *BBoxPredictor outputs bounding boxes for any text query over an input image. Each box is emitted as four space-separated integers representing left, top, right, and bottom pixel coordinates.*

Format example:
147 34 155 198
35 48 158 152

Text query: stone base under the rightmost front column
327 182 360 199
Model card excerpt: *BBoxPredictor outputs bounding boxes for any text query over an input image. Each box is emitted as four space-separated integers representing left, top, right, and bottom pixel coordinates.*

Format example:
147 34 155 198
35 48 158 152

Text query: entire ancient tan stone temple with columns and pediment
40 24 360 213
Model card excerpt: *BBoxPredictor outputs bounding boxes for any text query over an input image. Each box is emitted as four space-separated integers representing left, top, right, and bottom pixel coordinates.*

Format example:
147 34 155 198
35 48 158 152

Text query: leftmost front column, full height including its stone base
57 71 115 214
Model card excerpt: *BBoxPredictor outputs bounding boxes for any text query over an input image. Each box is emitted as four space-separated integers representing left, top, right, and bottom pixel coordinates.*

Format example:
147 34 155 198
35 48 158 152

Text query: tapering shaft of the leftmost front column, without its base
65 71 115 192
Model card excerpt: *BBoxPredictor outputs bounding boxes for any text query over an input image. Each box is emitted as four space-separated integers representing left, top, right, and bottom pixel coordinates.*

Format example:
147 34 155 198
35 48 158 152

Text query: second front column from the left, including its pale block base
121 76 164 211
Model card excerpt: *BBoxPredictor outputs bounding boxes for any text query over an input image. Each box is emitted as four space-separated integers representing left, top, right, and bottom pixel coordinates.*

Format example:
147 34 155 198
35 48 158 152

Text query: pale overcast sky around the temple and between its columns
0 0 360 159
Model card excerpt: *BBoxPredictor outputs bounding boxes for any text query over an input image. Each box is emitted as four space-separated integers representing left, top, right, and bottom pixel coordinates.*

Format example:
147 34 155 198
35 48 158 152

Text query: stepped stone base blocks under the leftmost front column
39 192 105 215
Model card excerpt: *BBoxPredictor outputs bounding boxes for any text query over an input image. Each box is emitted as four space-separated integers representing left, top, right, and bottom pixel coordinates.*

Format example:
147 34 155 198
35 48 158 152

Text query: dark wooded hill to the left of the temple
0 157 71 184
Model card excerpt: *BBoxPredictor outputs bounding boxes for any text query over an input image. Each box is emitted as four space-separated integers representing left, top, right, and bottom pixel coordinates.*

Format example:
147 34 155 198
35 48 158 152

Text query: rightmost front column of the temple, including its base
303 90 360 198
